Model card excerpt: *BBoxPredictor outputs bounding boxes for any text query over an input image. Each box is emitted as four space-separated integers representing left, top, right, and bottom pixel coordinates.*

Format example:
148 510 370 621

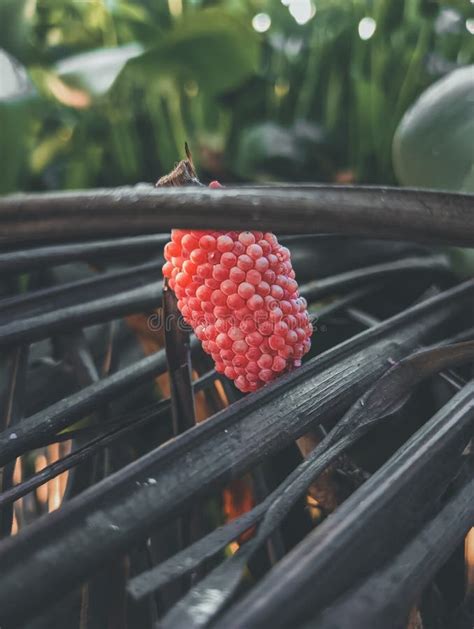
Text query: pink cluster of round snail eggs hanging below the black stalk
163 229 312 392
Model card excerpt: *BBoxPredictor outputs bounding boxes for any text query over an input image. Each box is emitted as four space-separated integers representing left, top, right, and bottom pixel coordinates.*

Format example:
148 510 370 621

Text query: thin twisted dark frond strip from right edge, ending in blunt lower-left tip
129 343 474 600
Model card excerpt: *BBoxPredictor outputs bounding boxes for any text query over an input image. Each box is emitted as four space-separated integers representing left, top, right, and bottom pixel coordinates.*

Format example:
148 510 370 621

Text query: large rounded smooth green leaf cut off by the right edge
393 66 474 192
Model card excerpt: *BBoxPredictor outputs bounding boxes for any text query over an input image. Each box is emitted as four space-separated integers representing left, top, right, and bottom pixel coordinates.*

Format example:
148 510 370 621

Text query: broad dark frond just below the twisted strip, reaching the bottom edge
216 382 474 628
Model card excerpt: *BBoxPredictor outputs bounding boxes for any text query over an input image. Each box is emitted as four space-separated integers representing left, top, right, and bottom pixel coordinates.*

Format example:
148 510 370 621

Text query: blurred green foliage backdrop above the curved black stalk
0 0 474 193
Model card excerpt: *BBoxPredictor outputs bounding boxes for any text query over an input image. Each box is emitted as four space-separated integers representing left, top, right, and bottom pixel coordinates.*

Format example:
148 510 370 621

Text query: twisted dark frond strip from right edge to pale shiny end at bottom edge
156 342 474 627
